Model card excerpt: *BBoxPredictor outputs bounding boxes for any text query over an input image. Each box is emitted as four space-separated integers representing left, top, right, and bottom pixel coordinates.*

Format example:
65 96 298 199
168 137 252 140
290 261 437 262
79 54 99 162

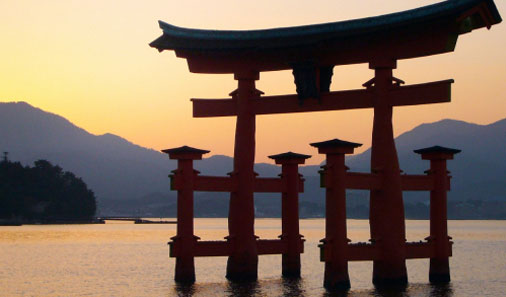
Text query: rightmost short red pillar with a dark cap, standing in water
415 146 460 283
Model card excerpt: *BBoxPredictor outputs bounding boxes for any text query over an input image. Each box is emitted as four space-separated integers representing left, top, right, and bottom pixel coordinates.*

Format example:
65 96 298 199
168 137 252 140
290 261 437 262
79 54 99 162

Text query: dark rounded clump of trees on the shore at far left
0 157 96 220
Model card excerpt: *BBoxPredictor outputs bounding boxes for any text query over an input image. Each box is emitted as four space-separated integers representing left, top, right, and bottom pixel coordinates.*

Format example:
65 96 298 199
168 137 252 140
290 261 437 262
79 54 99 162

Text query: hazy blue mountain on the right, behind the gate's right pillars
347 119 506 201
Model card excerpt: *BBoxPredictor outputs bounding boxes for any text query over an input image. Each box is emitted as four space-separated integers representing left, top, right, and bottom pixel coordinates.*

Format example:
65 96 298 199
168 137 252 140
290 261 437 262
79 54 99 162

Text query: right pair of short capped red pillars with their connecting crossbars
311 139 460 289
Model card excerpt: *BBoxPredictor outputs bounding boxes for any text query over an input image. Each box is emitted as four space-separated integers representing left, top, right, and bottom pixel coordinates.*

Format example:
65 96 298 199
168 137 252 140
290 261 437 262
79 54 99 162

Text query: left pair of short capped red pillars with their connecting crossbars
163 146 310 283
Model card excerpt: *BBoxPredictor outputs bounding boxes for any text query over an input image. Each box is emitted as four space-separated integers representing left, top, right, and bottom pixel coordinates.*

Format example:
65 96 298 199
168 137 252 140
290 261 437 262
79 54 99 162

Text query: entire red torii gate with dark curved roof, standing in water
150 0 501 289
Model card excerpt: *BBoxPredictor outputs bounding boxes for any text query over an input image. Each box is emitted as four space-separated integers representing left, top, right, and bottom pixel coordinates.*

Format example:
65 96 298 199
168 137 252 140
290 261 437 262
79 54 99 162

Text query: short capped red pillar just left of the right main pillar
311 139 361 290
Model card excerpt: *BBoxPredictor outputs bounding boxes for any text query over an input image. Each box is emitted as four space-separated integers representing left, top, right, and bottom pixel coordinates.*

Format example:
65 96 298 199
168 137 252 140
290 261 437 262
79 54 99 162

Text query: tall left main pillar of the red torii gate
226 72 260 281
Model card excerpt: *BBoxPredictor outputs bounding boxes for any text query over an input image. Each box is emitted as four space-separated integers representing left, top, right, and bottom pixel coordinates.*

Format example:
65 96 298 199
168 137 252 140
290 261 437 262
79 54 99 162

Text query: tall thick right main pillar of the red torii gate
369 59 407 286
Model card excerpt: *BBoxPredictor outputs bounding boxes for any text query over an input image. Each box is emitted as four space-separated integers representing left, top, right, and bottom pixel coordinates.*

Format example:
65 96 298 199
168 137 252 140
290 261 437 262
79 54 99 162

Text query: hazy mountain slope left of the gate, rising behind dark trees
0 102 174 201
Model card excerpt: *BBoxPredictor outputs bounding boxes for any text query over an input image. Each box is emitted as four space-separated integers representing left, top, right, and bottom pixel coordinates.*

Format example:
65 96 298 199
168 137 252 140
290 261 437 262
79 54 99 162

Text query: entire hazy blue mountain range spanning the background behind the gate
0 102 506 217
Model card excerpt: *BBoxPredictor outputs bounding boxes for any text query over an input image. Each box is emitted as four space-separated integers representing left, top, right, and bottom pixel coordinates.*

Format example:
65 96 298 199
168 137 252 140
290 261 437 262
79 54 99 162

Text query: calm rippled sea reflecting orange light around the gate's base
0 219 506 297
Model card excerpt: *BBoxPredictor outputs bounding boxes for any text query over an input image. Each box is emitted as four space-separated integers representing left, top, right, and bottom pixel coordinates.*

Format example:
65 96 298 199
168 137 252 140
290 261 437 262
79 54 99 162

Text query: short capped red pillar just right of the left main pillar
269 152 311 278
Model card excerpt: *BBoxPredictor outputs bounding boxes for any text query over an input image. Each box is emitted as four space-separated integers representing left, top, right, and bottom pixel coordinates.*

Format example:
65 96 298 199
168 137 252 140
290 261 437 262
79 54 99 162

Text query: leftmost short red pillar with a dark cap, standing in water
162 146 209 283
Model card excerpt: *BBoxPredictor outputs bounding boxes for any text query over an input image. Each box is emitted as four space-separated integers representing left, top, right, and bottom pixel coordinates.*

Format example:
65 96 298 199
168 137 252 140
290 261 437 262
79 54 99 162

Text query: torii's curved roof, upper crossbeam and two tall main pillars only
150 0 501 287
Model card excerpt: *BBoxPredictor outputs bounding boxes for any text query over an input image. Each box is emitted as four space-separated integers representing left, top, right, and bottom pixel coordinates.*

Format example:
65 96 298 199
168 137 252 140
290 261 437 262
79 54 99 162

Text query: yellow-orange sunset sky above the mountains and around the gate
0 0 506 164
